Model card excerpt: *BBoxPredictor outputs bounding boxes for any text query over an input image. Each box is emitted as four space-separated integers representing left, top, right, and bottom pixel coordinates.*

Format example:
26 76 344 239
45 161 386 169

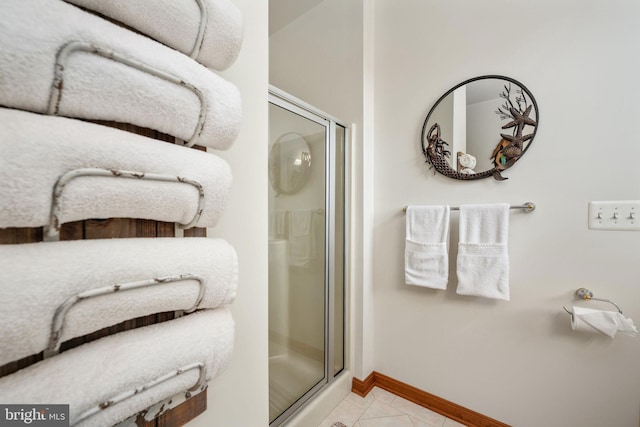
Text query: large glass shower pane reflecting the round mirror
269 100 327 422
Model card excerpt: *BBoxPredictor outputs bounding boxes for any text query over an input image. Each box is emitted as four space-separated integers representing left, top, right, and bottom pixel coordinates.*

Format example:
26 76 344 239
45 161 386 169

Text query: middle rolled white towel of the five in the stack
0 110 232 228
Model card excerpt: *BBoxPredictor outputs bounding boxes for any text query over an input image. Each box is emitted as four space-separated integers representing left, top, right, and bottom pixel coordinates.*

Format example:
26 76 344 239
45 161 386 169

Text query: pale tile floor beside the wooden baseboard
318 387 464 427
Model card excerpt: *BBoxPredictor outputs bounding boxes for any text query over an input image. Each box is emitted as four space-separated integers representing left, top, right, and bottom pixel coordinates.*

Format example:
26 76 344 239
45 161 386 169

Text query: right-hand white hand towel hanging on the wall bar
456 203 509 301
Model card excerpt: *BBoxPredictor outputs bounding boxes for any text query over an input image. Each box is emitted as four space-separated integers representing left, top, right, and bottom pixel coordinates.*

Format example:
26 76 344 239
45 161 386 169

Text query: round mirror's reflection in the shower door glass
269 132 311 194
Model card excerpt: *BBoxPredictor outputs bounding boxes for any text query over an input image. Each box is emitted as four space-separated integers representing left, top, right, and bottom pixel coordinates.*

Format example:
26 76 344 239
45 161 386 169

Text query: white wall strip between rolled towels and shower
188 0 269 427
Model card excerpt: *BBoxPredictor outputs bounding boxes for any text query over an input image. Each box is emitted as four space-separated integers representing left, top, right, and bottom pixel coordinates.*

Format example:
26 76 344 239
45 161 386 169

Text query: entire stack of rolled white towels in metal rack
0 0 243 426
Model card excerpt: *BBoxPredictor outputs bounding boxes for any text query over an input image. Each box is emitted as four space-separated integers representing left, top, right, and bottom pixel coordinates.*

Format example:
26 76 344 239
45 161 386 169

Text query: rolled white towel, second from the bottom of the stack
0 238 238 366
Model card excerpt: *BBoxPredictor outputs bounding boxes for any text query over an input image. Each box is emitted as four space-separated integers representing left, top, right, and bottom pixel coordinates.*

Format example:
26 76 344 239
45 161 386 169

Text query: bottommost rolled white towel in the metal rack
0 309 234 427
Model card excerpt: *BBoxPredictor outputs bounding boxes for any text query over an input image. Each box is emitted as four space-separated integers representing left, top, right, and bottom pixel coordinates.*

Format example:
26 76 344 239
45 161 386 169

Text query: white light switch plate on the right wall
589 200 640 231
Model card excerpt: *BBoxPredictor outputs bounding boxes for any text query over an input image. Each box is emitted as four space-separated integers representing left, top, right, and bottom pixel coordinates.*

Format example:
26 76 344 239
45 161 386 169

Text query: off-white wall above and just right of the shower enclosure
269 0 374 378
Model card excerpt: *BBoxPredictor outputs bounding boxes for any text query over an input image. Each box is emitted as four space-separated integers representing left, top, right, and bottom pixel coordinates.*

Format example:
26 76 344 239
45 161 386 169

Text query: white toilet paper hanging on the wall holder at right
571 306 638 338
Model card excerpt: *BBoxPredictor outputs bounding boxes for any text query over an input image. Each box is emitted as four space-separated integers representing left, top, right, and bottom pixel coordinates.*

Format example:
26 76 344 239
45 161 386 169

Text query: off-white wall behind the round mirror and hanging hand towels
374 0 640 427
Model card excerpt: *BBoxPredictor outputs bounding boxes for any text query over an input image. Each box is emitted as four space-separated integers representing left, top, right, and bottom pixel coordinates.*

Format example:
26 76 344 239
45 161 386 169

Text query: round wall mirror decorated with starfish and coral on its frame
421 76 539 181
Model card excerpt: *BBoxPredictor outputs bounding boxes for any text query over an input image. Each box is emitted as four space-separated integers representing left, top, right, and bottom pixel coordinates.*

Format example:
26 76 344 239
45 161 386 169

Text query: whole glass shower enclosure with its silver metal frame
269 87 347 426
